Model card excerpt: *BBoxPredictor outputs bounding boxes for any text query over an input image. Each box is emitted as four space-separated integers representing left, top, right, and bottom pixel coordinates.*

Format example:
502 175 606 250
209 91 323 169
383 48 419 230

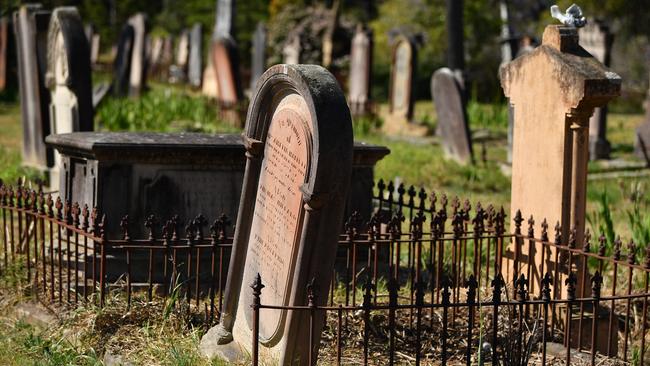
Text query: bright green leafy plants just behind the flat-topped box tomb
96 89 234 132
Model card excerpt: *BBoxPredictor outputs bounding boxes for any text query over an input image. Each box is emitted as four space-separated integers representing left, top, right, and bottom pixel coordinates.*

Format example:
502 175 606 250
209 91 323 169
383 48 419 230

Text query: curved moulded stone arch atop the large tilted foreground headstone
244 64 353 207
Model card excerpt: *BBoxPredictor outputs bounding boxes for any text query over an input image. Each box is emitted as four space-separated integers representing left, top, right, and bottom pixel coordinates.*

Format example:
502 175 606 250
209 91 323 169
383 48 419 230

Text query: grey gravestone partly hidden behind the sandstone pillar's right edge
579 21 614 160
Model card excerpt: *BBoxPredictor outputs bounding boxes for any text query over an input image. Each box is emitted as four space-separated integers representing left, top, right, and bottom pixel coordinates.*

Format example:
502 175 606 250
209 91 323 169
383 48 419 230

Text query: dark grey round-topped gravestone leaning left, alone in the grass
431 67 474 164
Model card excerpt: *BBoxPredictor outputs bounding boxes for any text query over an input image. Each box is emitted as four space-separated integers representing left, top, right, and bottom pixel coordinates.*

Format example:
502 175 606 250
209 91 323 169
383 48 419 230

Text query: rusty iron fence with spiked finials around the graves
0 181 650 365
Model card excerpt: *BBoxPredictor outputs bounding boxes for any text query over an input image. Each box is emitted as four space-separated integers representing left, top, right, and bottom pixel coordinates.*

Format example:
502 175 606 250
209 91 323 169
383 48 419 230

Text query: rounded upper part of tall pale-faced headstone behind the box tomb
46 6 91 92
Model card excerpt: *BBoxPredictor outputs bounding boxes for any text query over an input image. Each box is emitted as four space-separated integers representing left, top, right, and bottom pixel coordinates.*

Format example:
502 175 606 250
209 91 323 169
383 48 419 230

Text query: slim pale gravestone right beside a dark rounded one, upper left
129 13 147 97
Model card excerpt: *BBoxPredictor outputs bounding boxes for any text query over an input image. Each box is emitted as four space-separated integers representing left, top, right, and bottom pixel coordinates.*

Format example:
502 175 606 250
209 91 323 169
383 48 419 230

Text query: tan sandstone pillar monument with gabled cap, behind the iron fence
499 25 621 282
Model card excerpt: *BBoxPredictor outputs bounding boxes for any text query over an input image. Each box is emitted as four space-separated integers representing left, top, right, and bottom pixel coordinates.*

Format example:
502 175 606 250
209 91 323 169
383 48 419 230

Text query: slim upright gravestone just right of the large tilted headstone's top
348 24 372 115
